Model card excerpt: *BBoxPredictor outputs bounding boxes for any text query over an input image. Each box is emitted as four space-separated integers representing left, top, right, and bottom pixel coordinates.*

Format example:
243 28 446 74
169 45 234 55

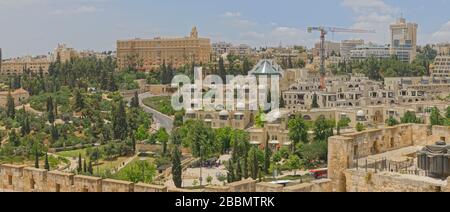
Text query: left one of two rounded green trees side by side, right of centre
288 115 309 152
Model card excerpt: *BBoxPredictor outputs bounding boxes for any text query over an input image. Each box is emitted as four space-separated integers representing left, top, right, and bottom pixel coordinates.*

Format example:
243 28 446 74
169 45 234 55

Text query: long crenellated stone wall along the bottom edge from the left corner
0 164 331 192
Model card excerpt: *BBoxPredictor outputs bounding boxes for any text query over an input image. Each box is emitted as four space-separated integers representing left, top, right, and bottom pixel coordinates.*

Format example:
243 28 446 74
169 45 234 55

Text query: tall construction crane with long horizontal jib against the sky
308 26 375 90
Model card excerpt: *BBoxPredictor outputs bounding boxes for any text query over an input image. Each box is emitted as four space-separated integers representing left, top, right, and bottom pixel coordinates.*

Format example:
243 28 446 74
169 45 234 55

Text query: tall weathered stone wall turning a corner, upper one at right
328 124 430 192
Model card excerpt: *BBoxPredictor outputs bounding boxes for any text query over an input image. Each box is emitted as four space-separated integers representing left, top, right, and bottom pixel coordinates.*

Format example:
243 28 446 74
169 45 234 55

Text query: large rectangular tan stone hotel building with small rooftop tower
117 27 212 71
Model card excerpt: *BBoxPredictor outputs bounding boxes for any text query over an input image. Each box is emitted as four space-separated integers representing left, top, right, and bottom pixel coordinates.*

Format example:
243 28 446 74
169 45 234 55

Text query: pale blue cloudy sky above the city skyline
0 0 450 58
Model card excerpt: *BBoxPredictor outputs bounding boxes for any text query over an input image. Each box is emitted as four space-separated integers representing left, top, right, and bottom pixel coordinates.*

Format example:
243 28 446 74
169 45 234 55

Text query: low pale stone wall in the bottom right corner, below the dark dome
345 169 448 192
